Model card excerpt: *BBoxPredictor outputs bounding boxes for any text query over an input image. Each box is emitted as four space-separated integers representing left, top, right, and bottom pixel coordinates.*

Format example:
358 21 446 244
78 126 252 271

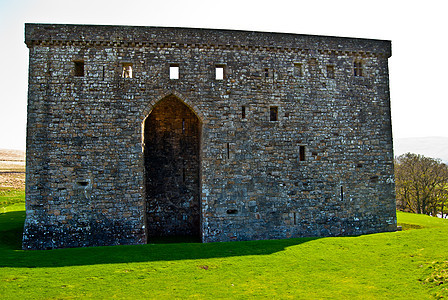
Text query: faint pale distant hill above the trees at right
394 137 448 163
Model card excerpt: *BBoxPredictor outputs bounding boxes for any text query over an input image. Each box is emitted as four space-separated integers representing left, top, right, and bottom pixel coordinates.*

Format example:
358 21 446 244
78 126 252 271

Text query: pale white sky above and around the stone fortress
0 0 448 150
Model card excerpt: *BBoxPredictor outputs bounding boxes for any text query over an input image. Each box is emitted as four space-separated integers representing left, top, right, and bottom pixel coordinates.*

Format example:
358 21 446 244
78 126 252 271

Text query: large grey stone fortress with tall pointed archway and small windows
23 24 397 249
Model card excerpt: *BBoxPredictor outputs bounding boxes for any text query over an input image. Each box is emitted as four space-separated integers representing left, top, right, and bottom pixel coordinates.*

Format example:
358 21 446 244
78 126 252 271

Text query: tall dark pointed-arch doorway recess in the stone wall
143 95 201 242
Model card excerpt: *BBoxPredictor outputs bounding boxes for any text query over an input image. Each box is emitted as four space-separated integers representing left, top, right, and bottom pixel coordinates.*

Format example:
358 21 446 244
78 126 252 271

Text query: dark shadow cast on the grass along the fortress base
0 212 318 268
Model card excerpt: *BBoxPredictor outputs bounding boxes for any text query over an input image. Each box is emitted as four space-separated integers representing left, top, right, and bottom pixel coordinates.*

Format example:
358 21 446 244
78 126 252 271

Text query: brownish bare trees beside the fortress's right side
395 153 448 218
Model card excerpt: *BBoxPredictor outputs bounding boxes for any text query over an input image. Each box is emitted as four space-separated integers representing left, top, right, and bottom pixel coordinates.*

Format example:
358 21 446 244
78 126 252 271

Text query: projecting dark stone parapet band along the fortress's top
25 23 392 57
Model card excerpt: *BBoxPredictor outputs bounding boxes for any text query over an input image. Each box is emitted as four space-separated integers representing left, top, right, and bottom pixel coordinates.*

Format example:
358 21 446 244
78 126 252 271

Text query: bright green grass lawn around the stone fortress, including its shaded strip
0 192 448 299
